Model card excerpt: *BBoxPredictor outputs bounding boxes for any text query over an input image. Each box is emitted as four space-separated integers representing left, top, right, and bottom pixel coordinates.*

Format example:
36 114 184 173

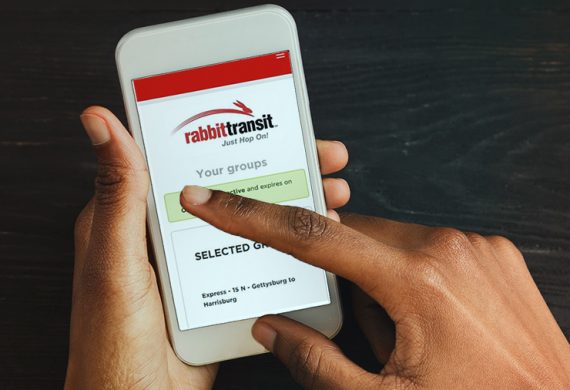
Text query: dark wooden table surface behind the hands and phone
0 0 570 389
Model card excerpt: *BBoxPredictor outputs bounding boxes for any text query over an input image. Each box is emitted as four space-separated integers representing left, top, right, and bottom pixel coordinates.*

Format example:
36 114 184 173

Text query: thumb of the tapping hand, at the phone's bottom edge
252 315 379 389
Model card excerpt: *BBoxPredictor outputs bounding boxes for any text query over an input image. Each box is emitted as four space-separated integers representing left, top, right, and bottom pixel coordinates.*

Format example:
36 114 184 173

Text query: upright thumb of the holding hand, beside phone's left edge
77 106 149 290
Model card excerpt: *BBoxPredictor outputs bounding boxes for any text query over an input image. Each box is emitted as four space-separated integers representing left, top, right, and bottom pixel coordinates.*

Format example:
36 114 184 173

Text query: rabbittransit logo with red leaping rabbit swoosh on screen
172 100 277 144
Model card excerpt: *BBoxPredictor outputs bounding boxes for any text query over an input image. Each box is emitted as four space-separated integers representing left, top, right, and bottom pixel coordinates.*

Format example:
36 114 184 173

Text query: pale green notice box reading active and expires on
164 169 309 222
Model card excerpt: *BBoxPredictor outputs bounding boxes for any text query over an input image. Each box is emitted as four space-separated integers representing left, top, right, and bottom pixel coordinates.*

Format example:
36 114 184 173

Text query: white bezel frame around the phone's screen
116 5 342 365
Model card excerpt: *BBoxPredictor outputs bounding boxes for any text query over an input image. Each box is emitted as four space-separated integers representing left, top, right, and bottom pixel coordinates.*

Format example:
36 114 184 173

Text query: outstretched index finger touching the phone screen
180 186 406 304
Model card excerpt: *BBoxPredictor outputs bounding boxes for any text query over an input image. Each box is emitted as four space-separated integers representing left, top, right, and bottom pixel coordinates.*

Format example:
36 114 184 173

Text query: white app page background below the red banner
134 75 330 330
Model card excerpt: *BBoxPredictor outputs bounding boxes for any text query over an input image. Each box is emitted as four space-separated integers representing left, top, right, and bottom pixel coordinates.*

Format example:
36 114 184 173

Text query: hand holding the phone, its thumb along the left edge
65 107 350 389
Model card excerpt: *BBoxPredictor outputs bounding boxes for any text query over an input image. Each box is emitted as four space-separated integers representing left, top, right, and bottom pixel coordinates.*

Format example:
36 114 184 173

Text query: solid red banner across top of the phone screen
133 51 291 102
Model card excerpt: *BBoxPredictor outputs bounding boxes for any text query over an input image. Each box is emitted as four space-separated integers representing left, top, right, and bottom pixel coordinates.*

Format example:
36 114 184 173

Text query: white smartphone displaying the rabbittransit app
116 5 342 365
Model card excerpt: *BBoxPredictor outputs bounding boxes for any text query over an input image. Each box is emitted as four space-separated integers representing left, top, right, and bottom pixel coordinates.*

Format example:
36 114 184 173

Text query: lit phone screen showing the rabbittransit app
133 51 330 330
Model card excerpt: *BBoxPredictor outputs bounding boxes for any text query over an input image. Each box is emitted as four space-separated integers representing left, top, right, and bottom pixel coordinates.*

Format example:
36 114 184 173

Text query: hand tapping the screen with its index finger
181 186 570 389
